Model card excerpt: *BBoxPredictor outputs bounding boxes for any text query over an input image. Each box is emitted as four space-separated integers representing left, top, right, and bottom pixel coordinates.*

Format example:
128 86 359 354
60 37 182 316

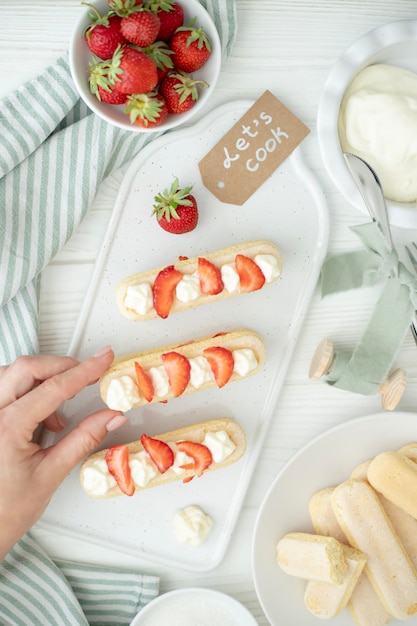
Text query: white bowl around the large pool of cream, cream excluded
317 20 417 228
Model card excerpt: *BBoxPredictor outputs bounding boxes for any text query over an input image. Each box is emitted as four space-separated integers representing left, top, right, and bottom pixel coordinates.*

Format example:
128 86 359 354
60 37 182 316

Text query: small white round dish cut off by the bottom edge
130 587 256 626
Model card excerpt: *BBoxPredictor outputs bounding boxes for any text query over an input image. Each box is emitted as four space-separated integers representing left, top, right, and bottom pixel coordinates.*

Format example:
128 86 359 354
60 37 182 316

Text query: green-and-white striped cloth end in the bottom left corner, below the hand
0 534 159 626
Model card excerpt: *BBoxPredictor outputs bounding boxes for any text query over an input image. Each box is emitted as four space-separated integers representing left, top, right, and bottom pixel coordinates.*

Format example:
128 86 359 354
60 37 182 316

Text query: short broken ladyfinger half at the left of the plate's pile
277 533 348 585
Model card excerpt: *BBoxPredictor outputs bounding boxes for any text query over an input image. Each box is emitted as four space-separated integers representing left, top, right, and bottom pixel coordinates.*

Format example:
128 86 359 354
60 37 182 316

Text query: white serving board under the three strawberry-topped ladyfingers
39 101 329 571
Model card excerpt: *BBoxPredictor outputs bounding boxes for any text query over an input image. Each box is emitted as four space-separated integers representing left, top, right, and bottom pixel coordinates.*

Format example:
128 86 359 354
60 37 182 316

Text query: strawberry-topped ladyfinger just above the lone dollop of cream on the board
80 418 246 498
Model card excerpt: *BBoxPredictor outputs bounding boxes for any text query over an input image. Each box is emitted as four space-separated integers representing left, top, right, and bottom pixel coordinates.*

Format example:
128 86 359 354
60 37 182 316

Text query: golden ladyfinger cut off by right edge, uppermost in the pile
368 451 417 518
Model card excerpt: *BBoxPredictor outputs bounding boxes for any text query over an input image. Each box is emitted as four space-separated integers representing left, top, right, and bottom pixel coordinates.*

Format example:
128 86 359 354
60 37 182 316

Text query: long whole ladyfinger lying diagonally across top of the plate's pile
332 480 417 619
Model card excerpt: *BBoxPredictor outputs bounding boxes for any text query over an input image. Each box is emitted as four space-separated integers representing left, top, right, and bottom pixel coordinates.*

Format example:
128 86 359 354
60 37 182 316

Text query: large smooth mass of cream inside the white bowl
338 63 417 202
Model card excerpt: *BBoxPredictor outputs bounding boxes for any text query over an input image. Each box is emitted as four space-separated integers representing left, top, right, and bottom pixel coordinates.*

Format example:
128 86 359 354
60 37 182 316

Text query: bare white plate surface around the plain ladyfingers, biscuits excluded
252 412 417 626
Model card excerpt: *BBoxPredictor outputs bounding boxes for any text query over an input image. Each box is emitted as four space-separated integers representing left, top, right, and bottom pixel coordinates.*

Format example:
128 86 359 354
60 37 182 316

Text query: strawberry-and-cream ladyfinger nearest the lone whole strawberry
116 240 282 320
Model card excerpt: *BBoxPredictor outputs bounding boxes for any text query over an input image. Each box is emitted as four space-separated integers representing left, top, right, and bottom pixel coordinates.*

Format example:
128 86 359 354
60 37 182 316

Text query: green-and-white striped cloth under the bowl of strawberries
0 0 236 365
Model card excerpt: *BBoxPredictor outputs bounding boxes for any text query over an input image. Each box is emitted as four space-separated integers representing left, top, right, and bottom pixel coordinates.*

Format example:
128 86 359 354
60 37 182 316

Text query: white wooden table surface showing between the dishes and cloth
0 0 417 624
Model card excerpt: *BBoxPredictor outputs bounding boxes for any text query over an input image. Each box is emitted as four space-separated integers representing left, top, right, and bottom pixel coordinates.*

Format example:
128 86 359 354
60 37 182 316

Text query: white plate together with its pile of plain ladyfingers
252 412 417 626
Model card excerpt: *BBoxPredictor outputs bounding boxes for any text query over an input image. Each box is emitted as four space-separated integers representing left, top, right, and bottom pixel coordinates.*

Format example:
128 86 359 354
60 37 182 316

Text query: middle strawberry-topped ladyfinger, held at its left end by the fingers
100 329 266 411
